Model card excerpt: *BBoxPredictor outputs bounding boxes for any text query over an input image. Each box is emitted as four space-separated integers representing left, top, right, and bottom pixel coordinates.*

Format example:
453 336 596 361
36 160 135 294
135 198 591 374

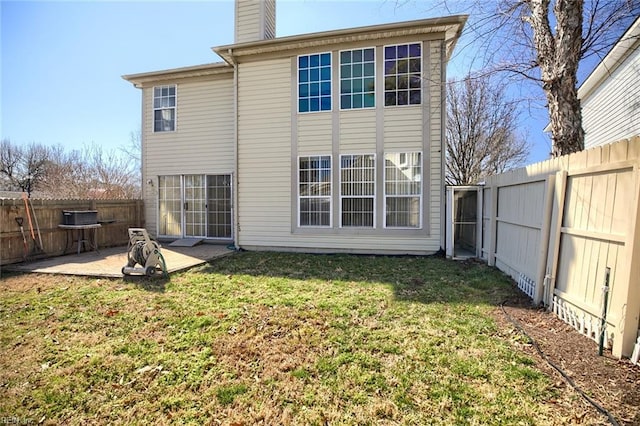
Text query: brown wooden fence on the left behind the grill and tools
0 198 144 265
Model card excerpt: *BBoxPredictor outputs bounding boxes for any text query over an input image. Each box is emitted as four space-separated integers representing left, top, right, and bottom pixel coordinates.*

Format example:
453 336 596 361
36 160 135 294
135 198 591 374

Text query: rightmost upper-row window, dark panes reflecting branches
384 43 422 106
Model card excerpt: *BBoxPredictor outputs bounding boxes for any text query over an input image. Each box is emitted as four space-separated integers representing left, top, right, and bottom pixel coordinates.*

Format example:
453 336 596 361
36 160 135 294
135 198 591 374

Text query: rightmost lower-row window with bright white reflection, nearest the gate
384 152 422 228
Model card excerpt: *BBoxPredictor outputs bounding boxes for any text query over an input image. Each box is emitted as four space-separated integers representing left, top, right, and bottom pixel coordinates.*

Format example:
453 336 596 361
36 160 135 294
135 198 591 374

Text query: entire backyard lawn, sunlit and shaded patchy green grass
0 252 556 425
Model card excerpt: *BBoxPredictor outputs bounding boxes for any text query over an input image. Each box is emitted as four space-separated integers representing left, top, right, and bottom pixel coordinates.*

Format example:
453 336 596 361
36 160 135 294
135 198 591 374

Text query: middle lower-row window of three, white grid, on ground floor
340 154 376 228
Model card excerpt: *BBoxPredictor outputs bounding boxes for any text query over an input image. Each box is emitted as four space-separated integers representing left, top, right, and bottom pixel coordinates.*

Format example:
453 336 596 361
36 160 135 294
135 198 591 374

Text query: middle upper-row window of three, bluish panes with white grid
340 48 376 109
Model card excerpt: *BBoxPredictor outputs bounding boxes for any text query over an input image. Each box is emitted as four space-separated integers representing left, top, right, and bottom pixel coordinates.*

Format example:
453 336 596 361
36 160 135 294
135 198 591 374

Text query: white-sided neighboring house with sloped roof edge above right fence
578 17 640 149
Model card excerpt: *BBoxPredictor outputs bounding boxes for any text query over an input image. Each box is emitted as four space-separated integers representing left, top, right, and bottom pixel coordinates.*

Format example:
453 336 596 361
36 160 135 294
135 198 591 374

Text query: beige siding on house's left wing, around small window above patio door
142 74 234 234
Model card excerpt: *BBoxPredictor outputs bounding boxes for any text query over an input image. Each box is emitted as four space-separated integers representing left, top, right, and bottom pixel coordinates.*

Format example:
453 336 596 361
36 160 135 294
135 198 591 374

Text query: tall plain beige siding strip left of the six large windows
237 58 295 247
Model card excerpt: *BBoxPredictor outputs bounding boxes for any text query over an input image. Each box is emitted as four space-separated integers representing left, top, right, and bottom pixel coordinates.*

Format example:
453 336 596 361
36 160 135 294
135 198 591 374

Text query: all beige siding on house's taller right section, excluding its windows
237 40 443 254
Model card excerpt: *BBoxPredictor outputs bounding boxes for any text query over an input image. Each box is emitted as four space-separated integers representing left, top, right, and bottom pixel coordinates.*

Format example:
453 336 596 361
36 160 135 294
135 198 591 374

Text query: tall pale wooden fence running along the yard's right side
482 136 640 362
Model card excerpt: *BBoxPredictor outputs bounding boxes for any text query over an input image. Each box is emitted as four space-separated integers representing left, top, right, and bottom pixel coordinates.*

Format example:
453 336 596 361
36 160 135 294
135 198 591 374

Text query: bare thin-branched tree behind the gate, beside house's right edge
445 76 528 185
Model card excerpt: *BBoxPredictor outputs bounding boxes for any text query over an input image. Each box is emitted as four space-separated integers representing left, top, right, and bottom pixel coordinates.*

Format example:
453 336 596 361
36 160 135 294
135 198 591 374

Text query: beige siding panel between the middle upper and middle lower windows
339 109 376 154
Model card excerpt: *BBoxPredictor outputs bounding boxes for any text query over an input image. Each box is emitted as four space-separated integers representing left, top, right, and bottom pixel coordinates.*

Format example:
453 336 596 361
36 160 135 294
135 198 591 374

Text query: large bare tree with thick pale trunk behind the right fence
432 0 640 155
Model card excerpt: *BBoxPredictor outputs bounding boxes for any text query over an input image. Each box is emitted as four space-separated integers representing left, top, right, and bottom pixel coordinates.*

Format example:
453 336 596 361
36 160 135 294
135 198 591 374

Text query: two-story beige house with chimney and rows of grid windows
123 0 467 254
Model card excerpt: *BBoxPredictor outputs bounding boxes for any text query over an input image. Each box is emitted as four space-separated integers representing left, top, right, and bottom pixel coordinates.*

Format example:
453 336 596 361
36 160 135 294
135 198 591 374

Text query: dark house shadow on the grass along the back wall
196 252 517 305
